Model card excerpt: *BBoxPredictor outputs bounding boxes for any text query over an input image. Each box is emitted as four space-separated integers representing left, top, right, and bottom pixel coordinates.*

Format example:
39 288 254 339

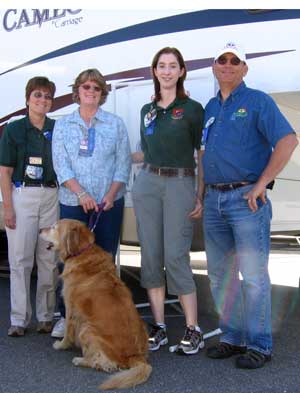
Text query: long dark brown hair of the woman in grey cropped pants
151 46 187 101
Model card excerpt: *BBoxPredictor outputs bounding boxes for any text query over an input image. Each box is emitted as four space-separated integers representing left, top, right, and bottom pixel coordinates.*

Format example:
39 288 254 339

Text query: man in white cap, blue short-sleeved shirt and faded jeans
199 43 298 369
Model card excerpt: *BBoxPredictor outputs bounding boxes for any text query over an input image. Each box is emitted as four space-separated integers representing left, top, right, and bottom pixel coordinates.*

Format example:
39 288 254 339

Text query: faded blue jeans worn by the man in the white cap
203 185 272 354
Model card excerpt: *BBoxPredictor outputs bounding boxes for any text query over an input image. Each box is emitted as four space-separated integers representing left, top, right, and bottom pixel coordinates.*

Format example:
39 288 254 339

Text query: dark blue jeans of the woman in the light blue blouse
57 197 124 317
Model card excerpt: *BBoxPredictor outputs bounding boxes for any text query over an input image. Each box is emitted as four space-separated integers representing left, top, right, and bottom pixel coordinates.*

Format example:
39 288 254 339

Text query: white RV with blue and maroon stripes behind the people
0 9 300 249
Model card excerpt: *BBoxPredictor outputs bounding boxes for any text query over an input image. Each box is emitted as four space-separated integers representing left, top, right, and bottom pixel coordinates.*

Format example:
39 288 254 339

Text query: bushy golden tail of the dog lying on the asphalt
99 361 152 390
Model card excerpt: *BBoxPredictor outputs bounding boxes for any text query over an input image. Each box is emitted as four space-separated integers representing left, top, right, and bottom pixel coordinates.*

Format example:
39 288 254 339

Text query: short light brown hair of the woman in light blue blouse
72 68 109 106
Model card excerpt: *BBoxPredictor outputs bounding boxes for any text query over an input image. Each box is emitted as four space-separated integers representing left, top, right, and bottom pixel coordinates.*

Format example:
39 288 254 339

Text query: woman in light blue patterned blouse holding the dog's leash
52 69 131 337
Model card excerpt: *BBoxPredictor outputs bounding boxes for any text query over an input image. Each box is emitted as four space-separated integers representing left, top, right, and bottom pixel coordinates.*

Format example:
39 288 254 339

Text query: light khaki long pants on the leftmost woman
6 187 58 327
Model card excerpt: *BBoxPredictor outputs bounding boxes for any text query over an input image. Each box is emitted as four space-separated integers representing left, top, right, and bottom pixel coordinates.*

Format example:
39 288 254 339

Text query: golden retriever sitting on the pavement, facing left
41 219 152 389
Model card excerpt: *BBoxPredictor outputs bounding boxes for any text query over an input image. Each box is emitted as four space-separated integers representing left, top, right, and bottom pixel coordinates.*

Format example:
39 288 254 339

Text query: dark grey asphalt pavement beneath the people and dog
0 242 300 393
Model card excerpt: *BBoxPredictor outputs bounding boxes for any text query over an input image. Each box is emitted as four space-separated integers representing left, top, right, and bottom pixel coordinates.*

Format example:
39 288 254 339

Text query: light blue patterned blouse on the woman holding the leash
52 108 131 206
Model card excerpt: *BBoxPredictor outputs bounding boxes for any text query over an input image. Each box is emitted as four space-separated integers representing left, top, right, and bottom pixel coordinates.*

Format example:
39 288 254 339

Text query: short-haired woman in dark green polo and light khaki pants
0 77 58 337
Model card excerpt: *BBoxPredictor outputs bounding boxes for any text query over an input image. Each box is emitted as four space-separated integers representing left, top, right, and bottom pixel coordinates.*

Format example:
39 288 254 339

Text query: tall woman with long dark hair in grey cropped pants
133 47 204 355
